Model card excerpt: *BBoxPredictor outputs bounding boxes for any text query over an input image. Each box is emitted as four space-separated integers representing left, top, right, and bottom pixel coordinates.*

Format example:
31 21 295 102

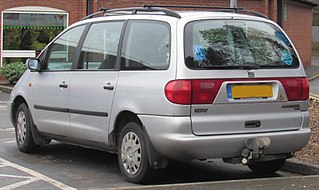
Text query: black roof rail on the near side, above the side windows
81 6 181 20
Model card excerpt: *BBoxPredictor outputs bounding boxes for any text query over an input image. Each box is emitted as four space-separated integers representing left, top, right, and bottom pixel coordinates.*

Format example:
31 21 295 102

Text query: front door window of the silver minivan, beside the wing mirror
46 25 85 70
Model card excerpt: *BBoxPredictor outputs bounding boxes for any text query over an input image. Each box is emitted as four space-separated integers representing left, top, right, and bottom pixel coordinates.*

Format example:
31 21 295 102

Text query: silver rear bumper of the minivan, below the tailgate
139 112 311 160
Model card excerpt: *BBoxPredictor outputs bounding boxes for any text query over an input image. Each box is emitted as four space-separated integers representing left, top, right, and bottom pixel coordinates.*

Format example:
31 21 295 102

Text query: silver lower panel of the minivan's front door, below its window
29 72 71 136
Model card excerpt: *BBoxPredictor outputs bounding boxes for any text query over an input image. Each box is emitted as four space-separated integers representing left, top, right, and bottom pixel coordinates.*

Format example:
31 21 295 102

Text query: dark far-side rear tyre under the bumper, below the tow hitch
248 159 286 174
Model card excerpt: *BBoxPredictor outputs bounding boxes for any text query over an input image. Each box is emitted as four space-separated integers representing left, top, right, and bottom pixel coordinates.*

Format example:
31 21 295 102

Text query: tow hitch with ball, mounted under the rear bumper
241 137 271 165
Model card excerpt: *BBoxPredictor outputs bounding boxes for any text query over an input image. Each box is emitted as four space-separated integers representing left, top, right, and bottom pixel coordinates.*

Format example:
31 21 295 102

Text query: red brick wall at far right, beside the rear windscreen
283 1 312 66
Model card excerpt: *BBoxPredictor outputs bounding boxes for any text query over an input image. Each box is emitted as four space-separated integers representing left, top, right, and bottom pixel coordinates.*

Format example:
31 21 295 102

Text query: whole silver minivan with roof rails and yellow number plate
8 6 311 183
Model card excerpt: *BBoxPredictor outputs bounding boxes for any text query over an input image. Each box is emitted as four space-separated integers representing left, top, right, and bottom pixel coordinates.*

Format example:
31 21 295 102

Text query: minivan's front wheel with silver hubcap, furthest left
15 103 39 153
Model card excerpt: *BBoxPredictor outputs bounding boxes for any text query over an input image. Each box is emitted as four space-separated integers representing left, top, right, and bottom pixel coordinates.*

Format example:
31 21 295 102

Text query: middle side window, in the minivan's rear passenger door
81 22 123 70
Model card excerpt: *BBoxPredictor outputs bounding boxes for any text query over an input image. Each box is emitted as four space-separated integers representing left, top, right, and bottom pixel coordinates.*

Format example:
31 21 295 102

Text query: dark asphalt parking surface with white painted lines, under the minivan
0 93 298 190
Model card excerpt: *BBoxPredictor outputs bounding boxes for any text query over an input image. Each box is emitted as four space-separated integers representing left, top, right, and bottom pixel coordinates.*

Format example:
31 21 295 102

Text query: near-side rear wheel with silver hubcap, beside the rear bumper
118 122 155 183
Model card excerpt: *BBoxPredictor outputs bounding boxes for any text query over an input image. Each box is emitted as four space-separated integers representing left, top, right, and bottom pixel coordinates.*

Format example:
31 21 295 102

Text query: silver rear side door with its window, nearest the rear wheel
68 21 124 143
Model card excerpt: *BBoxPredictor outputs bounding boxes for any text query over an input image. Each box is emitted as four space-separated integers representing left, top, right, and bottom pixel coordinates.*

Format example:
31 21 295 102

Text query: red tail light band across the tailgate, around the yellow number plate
165 77 309 105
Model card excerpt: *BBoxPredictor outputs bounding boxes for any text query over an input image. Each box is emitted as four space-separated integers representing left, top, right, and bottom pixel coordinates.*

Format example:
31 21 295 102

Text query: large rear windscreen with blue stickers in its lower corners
185 20 299 69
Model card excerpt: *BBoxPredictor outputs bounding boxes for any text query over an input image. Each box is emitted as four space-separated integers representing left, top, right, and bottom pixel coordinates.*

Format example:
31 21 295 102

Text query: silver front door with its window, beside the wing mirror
31 25 85 136
